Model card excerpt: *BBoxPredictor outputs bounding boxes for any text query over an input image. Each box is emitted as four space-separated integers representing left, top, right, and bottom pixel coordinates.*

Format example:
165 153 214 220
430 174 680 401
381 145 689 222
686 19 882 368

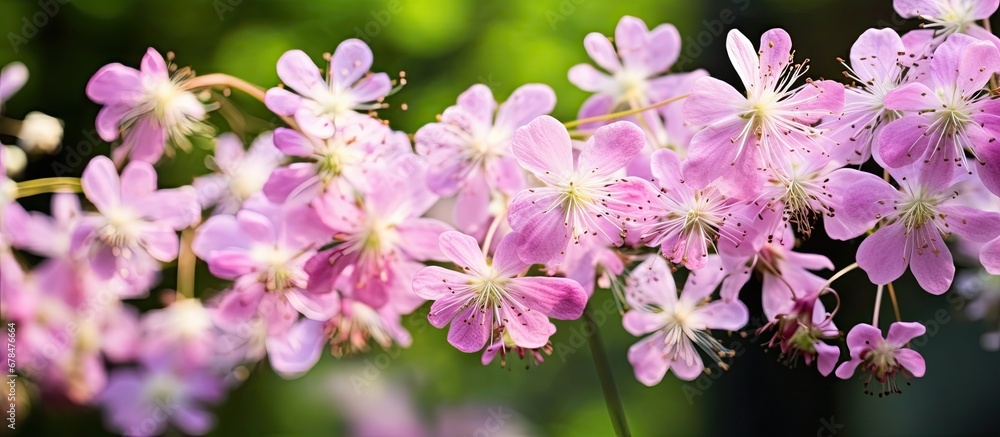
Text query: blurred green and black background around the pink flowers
0 0 1000 436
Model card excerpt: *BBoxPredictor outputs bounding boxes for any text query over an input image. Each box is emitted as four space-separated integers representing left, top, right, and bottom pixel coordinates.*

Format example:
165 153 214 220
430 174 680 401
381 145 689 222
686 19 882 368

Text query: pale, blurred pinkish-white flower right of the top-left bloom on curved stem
193 132 284 214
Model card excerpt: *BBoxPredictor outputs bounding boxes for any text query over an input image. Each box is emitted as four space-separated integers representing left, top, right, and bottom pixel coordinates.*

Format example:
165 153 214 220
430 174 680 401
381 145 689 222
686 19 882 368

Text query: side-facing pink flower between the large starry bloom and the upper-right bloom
821 29 918 164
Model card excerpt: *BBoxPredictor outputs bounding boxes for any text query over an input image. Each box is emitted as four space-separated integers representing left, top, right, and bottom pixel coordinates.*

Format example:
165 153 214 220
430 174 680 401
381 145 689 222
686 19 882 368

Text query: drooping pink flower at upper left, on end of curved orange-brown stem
87 49 206 163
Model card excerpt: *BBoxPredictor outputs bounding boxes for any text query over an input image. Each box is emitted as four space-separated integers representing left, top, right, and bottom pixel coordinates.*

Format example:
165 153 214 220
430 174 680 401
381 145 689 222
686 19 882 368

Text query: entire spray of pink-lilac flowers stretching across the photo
0 0 1000 435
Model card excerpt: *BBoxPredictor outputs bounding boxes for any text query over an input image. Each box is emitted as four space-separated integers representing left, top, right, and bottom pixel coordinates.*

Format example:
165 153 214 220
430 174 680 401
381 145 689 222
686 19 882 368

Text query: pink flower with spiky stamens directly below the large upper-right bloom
640 150 756 270
